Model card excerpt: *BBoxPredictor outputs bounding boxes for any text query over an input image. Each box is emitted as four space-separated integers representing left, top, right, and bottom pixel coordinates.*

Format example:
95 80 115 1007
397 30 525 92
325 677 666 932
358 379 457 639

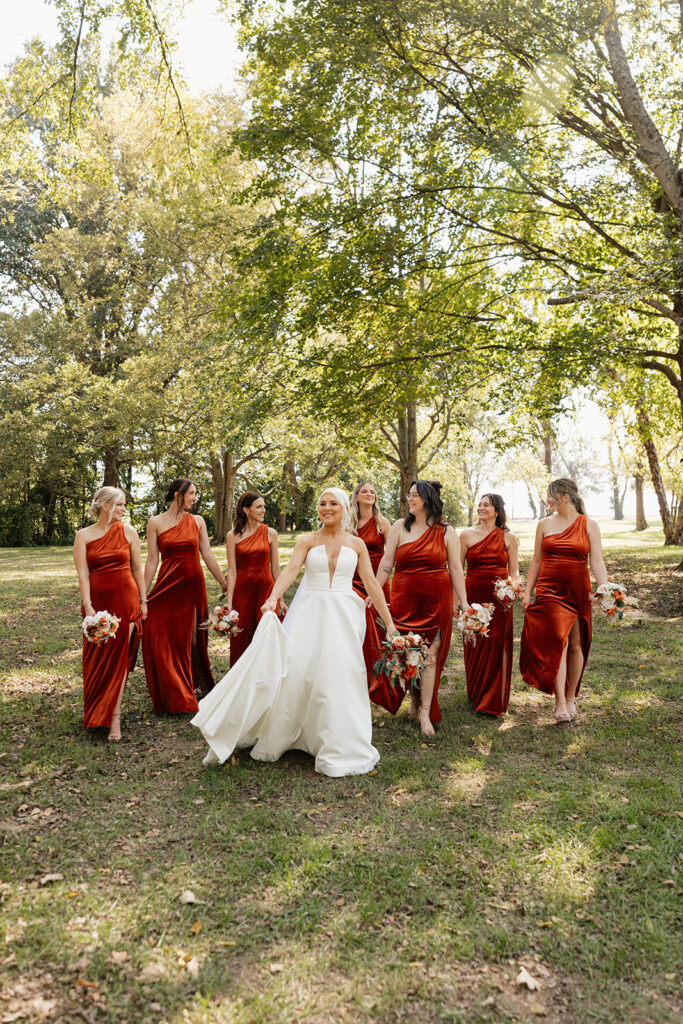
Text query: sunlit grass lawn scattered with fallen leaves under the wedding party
0 523 683 1024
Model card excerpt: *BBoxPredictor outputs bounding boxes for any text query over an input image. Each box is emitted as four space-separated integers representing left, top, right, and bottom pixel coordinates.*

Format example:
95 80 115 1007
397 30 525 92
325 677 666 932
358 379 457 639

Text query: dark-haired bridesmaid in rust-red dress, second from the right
460 494 519 715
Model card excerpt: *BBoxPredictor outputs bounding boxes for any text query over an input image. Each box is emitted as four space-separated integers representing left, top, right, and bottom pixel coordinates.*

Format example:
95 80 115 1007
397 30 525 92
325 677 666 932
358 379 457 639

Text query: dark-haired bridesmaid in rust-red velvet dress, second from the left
142 478 227 715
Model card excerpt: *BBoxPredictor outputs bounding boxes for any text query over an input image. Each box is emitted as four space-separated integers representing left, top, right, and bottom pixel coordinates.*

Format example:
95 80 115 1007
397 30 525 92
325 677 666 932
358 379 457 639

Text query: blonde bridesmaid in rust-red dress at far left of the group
74 487 146 740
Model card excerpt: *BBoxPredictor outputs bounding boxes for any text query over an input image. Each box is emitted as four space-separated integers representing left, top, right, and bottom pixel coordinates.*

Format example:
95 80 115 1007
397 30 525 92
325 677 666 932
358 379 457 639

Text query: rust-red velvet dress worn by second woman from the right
463 526 513 715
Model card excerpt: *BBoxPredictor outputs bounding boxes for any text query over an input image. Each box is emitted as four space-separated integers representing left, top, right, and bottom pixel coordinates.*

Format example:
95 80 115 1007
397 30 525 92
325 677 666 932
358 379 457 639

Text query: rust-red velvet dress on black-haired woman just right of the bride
370 523 453 725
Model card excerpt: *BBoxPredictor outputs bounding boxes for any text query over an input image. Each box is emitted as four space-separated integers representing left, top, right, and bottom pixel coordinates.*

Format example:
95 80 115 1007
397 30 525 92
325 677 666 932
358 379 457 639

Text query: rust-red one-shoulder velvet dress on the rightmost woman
519 515 593 693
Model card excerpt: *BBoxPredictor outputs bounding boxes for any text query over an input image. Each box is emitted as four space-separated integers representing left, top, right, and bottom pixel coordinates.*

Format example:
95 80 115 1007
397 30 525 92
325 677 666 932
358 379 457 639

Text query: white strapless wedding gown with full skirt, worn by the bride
193 544 380 776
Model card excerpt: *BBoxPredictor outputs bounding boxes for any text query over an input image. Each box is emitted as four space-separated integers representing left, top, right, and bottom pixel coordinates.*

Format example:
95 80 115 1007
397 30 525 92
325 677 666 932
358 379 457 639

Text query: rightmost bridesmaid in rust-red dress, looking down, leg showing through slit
519 478 607 722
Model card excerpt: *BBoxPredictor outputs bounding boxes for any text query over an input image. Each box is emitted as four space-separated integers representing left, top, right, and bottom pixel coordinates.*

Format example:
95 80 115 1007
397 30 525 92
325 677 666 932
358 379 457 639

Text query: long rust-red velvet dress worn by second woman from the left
142 513 214 715
